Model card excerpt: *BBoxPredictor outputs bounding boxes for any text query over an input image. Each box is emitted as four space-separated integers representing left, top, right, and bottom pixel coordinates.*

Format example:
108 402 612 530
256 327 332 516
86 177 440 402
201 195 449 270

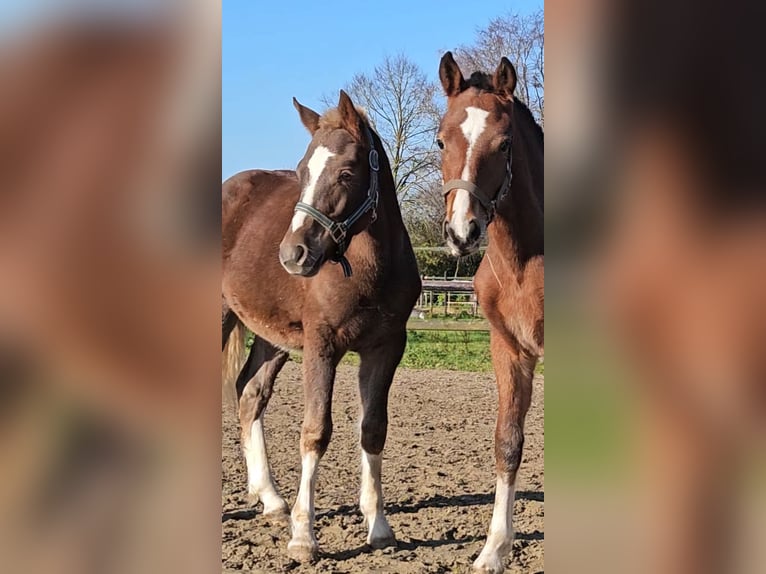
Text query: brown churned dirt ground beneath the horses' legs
222 362 544 574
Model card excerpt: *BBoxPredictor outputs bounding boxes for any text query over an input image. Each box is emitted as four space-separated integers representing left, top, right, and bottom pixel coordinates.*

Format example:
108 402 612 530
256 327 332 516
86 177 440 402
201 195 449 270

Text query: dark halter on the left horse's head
295 127 380 277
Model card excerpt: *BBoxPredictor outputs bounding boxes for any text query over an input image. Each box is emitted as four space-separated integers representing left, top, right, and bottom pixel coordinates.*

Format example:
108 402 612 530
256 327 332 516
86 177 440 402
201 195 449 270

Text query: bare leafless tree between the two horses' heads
325 55 441 203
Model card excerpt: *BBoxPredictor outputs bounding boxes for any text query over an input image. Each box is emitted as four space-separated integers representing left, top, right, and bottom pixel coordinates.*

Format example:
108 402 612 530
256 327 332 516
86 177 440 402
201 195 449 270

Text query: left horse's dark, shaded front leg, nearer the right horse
359 332 407 548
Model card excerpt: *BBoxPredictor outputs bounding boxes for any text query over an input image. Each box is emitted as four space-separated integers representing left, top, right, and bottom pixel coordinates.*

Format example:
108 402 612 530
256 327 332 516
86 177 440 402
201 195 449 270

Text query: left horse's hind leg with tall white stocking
237 337 288 514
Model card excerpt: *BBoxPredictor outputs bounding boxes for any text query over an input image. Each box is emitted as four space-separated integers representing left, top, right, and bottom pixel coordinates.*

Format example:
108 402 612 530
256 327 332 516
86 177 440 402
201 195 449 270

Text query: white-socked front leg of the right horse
473 329 537 574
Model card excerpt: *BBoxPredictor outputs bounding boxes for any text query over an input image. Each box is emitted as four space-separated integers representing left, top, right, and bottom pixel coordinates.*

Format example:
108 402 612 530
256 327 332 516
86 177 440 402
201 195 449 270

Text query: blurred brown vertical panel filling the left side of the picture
0 1 221 574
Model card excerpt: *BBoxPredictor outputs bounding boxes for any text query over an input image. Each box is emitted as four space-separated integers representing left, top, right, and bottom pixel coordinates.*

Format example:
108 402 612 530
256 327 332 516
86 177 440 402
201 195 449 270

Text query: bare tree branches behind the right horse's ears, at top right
455 10 545 125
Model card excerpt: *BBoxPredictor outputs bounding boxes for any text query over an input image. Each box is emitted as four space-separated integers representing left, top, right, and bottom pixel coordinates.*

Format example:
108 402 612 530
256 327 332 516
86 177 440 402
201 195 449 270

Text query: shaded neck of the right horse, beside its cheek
488 112 544 268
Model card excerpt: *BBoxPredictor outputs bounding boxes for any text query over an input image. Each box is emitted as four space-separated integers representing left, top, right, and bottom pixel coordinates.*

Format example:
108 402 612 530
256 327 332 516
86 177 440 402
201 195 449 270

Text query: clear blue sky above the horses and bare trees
222 0 542 179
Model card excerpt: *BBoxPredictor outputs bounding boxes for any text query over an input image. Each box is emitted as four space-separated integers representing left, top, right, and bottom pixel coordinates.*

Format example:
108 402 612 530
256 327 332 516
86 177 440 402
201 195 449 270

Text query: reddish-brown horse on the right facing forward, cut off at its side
437 52 544 573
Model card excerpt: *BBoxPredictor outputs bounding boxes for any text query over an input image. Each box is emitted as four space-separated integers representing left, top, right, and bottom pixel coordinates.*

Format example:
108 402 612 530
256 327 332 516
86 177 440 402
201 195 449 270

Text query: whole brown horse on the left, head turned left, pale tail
222 91 420 562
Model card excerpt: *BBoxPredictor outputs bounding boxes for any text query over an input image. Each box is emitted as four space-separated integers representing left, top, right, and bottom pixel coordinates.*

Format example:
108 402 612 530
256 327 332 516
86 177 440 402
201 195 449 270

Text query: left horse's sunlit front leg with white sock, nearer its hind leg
287 341 339 562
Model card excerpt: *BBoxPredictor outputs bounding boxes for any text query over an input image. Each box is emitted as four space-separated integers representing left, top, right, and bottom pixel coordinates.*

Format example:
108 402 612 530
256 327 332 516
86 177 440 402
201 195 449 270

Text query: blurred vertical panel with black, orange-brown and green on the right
545 0 766 573
